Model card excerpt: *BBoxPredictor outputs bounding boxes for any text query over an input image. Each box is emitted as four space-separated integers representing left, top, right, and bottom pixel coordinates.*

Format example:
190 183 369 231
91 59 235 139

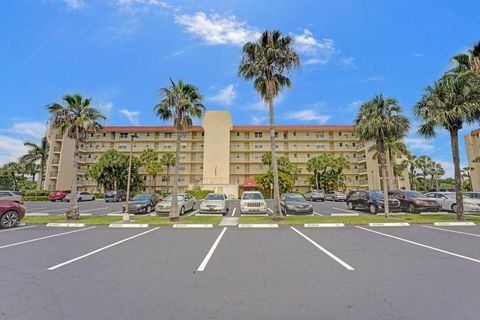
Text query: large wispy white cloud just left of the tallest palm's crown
175 12 260 46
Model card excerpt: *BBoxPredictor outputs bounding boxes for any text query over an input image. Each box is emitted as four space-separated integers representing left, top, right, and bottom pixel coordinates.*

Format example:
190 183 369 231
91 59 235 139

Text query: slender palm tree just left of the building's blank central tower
154 78 205 221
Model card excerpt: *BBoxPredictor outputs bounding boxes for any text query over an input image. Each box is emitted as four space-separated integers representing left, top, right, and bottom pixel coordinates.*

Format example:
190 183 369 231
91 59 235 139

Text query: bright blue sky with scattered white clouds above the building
0 0 480 175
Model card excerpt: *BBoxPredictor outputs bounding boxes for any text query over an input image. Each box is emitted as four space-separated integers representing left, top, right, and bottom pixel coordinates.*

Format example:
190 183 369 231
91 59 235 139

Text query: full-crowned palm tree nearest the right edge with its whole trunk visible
415 73 480 220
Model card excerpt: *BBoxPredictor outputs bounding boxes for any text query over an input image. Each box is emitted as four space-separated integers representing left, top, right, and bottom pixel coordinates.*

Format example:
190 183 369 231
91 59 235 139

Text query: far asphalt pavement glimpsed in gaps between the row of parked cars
25 200 360 217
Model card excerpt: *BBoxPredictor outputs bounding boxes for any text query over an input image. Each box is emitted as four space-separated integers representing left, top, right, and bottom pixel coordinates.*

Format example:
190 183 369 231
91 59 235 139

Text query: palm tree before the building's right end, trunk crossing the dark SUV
355 95 410 218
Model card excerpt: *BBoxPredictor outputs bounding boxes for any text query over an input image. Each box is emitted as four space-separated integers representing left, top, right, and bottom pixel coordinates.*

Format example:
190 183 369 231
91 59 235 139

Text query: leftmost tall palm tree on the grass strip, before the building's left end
47 94 106 219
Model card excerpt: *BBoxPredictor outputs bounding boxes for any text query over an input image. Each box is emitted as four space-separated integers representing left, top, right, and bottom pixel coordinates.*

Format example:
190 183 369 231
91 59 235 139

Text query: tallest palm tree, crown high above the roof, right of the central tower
238 30 300 219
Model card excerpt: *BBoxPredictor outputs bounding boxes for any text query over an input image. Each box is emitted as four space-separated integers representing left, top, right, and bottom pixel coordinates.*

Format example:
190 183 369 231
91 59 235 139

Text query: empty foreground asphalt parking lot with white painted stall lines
0 225 480 320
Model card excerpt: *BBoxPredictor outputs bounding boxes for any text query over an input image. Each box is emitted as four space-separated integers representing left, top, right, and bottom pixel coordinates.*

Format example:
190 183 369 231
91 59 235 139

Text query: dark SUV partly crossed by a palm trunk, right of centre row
347 190 400 214
